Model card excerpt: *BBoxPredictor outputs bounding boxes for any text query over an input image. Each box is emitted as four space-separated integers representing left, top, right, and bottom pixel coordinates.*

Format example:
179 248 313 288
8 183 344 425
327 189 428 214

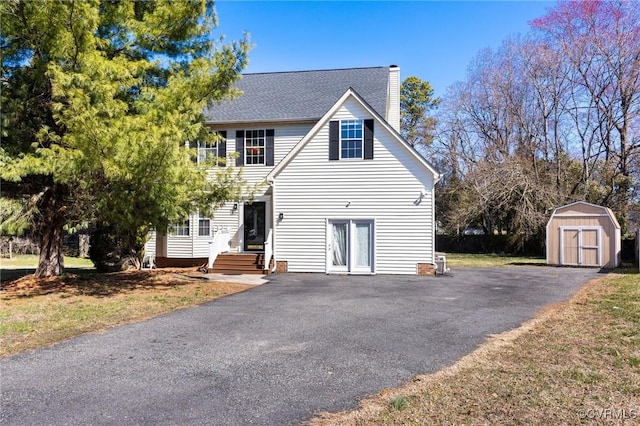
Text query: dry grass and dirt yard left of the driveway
0 268 252 355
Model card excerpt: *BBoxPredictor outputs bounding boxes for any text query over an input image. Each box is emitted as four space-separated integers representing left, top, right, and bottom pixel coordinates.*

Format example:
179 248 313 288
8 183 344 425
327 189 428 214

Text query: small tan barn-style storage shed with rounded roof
547 201 622 268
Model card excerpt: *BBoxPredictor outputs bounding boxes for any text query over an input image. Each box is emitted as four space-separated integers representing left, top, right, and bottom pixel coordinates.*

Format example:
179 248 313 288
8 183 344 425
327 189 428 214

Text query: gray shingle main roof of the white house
205 67 389 123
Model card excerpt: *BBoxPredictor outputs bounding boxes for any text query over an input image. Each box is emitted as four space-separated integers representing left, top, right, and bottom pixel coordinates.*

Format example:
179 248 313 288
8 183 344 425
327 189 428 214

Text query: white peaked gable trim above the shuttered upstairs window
267 88 440 184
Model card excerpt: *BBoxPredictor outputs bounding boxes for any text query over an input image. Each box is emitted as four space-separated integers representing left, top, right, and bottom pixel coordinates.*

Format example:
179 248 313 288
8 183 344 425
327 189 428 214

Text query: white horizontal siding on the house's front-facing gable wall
274 100 434 274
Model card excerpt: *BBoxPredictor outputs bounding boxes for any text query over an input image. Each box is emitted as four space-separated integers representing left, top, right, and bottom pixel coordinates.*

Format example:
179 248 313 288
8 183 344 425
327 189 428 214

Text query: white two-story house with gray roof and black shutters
145 66 439 275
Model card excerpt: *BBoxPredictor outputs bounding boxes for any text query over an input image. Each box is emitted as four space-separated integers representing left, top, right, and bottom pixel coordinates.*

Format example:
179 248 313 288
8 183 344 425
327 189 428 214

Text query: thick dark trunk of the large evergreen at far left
35 184 66 278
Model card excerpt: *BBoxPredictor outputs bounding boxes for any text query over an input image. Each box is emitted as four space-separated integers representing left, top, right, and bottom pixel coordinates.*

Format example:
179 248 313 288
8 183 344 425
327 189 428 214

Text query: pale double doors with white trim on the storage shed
560 227 602 266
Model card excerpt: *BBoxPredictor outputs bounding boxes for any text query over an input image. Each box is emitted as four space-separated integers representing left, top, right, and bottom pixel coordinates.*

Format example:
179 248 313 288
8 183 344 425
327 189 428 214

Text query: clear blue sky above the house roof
216 0 555 96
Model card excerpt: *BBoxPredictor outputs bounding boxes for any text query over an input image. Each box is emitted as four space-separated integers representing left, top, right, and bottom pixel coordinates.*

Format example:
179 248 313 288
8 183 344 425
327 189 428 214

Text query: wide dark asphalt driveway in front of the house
0 267 598 425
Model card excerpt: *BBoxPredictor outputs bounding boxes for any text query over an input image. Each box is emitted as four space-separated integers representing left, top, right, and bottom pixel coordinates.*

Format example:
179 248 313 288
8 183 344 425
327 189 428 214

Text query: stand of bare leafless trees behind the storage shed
428 1 640 241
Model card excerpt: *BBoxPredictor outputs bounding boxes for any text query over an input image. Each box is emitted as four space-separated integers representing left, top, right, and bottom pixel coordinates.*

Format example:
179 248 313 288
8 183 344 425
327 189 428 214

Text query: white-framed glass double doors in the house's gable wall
327 220 374 274
